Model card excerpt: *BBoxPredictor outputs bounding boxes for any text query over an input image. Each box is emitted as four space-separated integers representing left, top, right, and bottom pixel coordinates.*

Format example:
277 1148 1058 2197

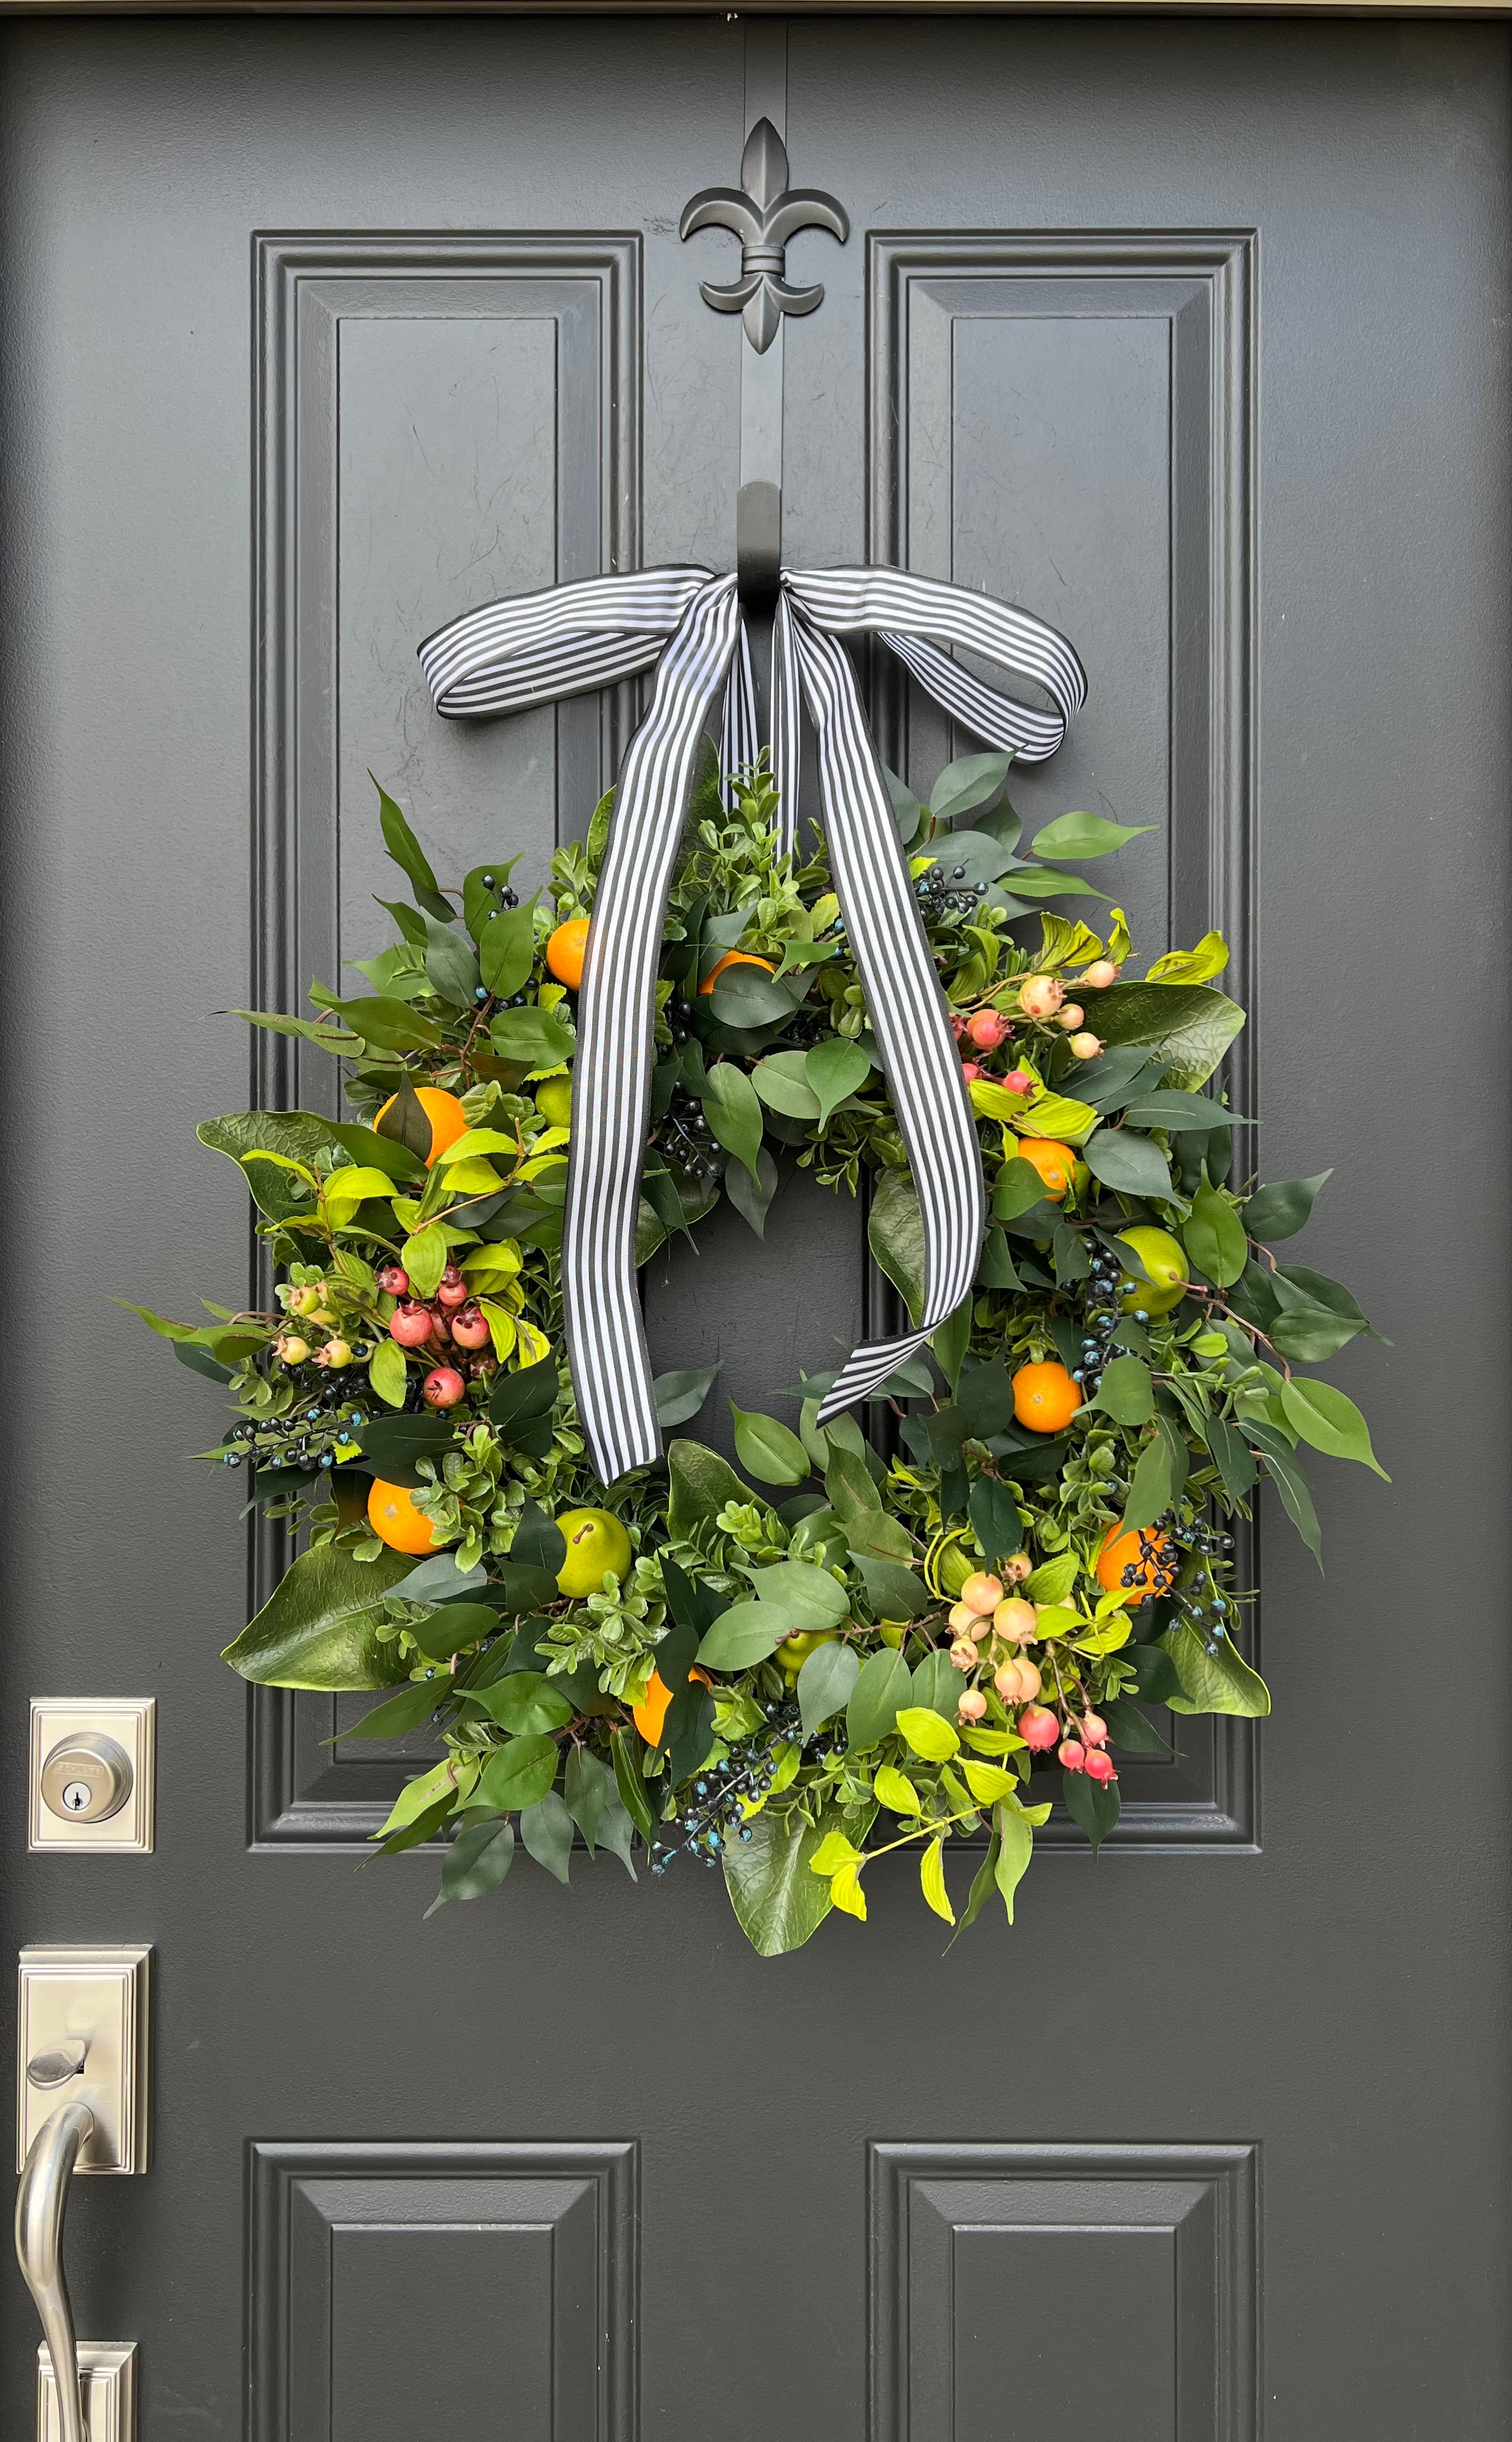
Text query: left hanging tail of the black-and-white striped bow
562 577 735 1484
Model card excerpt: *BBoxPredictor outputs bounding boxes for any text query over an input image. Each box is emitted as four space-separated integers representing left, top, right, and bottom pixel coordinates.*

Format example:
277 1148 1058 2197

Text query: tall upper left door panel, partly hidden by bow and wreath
246 230 642 1846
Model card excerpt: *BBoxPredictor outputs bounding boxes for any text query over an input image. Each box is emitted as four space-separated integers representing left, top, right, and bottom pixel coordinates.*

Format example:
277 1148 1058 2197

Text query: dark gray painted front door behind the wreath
0 17 1512 2442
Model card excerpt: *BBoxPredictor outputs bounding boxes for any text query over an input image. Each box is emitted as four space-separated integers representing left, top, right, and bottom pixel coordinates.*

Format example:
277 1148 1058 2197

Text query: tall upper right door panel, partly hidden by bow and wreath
867 230 1258 1851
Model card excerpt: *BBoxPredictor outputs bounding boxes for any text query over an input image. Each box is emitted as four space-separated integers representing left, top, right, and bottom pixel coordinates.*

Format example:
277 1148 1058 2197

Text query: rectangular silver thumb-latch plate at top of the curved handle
15 1941 151 2176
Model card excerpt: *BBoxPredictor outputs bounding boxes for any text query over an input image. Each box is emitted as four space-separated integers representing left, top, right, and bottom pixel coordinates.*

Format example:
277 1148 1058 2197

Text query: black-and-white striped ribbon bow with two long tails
420 566 1087 1484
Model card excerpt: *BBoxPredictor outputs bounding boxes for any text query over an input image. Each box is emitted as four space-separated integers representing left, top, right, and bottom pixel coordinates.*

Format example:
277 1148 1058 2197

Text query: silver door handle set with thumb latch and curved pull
15 1944 151 2442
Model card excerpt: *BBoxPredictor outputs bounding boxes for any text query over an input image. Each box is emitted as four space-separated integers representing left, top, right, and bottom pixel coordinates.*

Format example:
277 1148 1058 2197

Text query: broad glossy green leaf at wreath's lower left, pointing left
222 1543 413 1692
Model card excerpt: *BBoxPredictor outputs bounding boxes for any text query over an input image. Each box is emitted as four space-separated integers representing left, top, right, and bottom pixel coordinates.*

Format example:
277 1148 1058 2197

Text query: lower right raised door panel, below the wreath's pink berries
867 2144 1261 2442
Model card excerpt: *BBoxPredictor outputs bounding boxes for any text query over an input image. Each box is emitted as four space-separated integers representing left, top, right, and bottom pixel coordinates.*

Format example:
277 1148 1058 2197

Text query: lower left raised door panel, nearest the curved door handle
246 2139 640 2442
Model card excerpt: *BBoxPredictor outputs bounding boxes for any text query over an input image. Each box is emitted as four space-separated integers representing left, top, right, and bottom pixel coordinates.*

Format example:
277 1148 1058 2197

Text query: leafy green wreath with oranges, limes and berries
134 750 1380 1956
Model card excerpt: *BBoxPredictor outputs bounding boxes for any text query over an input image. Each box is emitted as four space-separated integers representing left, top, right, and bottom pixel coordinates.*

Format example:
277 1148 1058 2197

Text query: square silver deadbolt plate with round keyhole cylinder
29 1697 156 1851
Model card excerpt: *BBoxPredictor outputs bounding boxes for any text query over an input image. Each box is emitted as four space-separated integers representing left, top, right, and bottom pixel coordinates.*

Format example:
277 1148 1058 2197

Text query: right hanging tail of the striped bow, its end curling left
791 618 987 1424
